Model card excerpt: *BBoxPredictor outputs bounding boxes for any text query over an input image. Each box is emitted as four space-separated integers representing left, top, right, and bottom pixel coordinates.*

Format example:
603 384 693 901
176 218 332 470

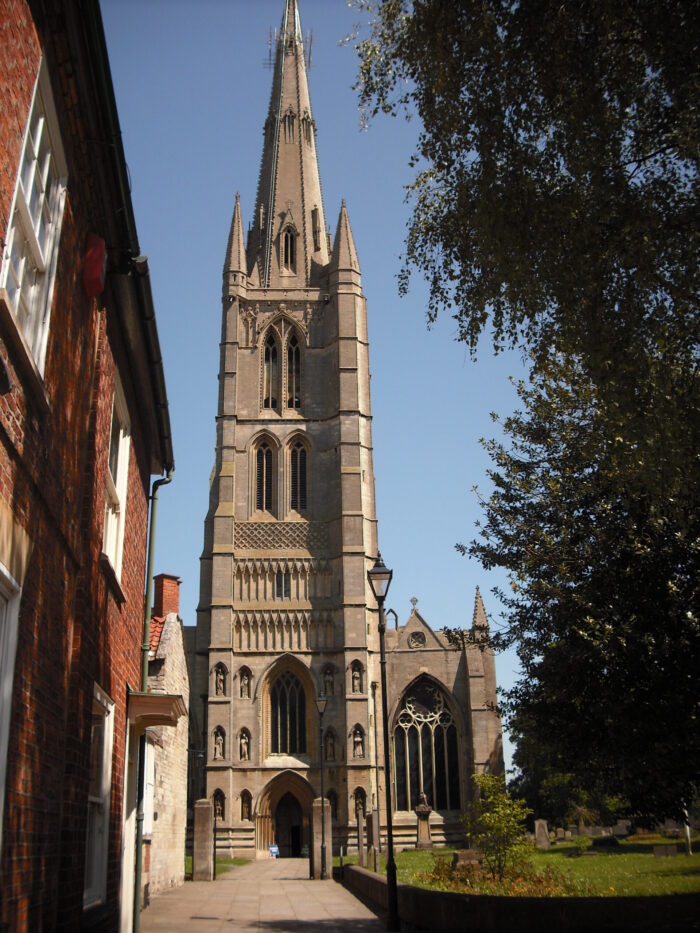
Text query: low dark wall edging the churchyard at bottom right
343 865 700 933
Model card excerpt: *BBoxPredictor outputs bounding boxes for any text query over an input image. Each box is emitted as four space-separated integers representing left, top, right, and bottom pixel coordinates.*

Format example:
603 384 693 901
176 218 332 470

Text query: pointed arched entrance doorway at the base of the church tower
255 771 314 858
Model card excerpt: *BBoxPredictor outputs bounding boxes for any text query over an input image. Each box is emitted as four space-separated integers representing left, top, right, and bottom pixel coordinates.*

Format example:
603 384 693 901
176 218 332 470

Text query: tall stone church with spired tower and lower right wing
191 0 503 857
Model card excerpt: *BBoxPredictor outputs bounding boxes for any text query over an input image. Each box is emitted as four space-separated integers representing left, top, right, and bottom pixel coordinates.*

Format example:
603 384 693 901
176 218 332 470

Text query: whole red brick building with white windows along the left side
0 0 182 933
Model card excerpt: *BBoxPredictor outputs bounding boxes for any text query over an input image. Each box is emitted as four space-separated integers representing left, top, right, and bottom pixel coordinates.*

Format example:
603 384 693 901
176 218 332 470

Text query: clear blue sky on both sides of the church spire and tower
101 0 522 763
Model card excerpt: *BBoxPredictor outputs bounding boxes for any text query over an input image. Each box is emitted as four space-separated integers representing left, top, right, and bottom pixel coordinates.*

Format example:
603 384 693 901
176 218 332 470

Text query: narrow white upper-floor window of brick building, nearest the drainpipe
102 378 131 580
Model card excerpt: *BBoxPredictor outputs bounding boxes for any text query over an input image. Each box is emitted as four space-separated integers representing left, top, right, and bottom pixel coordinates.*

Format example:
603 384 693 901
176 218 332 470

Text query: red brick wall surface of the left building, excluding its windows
0 0 159 933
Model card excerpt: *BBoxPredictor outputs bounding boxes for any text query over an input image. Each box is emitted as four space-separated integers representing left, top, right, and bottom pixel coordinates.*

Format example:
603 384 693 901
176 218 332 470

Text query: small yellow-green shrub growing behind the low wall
464 774 530 881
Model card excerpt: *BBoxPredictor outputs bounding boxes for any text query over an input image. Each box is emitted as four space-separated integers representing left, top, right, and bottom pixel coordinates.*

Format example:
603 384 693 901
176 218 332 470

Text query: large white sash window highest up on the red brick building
0 60 68 375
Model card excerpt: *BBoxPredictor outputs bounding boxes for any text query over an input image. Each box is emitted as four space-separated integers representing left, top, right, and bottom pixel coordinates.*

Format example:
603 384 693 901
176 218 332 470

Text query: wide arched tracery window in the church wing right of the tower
394 677 461 810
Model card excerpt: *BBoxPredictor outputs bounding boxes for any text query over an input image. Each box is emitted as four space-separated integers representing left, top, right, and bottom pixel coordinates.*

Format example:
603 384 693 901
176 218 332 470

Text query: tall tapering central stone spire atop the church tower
247 0 329 288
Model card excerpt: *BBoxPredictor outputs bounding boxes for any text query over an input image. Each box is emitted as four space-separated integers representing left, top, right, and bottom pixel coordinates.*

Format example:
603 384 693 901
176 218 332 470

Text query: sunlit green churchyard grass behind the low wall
334 838 700 896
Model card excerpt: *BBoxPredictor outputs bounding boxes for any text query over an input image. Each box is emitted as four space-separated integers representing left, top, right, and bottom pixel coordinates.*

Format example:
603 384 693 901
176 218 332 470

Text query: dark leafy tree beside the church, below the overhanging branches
460 358 700 818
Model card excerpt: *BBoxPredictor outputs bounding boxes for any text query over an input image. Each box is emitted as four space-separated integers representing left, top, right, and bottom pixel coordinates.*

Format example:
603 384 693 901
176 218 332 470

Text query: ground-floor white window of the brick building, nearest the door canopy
83 684 114 908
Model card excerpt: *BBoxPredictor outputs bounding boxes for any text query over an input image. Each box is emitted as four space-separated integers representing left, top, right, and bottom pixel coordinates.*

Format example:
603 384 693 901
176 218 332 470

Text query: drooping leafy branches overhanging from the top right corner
355 0 700 384
